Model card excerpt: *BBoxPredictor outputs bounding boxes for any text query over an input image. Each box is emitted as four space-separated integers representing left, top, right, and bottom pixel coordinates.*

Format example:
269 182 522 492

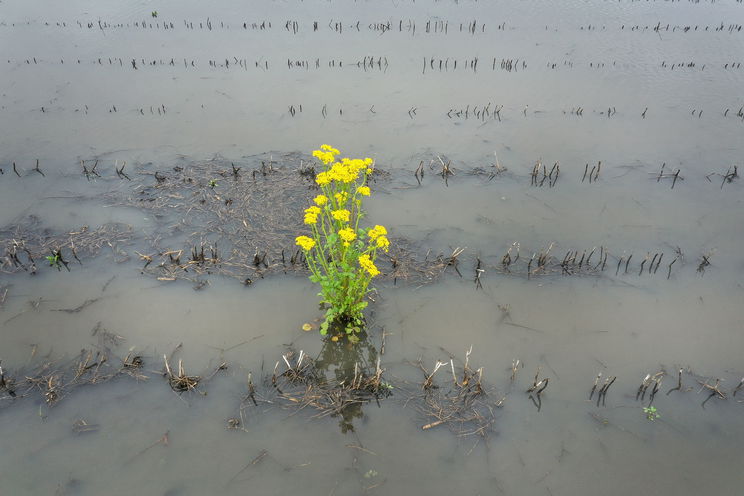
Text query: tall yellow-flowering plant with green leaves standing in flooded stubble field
296 145 390 335
